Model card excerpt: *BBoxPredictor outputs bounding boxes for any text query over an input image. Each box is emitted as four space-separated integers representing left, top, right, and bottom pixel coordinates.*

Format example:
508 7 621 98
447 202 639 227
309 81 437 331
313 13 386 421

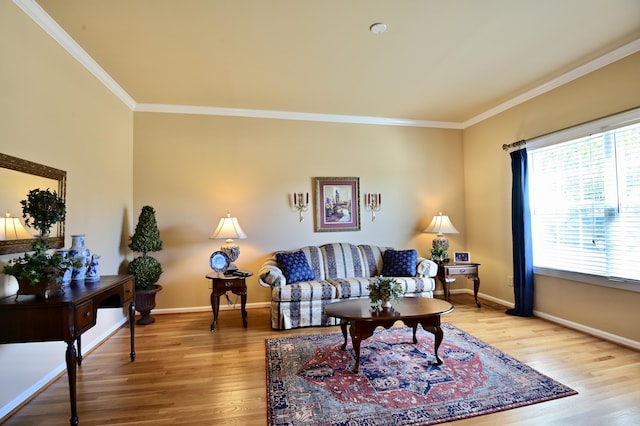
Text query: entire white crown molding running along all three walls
13 0 640 129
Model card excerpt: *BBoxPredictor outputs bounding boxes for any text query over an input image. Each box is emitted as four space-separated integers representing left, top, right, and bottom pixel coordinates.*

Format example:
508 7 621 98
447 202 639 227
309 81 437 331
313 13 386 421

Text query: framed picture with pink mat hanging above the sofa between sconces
314 177 360 232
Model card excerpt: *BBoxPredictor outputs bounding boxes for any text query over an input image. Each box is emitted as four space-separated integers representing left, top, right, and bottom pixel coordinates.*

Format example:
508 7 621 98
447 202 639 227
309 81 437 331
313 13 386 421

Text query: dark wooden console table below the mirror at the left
0 275 136 425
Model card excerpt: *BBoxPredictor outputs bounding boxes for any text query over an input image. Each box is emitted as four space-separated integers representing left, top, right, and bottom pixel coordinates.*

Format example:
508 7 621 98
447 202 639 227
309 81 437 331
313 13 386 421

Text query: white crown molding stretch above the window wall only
462 39 640 129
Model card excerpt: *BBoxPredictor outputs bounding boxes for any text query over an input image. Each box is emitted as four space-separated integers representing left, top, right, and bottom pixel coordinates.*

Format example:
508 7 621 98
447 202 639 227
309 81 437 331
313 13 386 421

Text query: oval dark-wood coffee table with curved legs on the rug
324 297 453 373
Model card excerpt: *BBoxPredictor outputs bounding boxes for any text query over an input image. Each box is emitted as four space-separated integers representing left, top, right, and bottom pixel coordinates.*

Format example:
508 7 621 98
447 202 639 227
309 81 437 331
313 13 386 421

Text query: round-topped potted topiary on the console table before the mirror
3 188 74 299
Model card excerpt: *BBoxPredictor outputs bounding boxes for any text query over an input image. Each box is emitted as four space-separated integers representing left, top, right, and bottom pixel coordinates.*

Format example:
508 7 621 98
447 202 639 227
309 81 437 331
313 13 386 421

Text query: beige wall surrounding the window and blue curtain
464 54 640 342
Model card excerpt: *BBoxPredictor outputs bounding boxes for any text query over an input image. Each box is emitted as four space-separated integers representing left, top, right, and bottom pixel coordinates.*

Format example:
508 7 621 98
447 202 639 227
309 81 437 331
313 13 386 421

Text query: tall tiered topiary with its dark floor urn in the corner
127 206 162 325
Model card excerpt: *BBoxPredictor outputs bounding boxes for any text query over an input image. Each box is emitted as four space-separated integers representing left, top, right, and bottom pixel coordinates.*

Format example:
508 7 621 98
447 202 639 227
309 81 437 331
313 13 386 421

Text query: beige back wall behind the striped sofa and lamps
134 113 464 310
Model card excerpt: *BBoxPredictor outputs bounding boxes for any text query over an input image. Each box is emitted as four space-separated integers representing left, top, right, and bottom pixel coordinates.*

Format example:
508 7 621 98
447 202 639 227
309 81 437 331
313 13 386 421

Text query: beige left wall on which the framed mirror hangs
0 1 133 419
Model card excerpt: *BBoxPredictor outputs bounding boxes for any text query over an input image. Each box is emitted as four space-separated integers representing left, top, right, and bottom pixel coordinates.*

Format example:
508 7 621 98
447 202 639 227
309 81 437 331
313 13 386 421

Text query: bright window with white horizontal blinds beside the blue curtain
527 111 640 287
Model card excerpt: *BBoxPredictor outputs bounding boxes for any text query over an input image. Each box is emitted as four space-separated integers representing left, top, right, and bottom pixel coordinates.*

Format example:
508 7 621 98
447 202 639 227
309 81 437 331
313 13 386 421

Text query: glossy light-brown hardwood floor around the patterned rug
3 295 640 426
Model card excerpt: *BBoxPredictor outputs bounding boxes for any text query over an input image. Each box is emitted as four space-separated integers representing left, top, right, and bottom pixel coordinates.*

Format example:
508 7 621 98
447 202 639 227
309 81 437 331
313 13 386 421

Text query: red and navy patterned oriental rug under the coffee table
266 323 577 426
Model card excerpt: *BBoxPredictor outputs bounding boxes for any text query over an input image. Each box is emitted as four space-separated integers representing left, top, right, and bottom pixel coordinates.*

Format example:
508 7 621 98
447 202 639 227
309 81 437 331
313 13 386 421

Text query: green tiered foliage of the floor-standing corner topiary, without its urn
127 206 162 290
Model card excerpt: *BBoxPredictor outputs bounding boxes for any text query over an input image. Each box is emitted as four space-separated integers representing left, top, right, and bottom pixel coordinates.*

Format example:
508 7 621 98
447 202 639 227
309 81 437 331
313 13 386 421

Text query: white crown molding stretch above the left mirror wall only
13 0 136 110
